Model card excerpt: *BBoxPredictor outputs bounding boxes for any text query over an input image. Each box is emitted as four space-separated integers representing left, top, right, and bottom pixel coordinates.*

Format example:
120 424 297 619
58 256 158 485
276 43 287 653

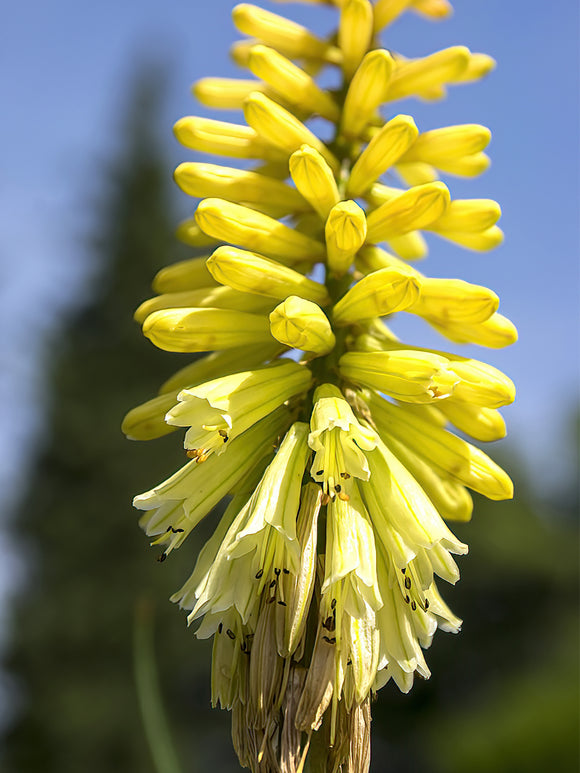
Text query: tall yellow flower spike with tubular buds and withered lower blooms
123 0 517 773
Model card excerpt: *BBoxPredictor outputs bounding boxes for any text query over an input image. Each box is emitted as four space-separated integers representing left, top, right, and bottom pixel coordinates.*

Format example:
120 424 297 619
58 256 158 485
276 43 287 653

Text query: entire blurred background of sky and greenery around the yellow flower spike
0 0 579 773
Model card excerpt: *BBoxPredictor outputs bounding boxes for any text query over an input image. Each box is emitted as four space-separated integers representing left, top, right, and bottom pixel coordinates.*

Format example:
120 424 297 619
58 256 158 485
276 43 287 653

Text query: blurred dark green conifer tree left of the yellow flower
0 67 236 773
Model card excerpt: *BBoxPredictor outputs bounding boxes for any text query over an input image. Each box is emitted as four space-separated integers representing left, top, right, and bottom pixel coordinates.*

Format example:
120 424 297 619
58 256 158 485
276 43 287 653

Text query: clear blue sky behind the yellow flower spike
0 0 579 620
